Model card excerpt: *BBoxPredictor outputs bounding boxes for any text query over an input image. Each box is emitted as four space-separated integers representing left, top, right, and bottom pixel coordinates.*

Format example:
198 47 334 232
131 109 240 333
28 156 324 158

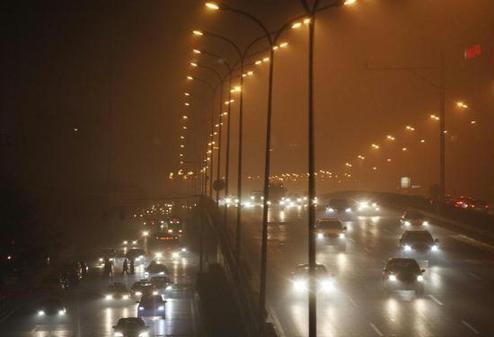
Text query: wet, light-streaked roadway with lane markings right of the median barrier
230 202 494 337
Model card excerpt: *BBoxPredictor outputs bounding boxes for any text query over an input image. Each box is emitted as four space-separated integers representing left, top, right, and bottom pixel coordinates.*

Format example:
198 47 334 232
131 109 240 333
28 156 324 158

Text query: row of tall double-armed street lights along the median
178 0 356 336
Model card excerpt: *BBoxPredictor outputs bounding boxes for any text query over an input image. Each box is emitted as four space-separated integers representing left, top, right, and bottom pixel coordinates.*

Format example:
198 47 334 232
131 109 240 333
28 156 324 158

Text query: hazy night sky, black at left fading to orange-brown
1 0 494 200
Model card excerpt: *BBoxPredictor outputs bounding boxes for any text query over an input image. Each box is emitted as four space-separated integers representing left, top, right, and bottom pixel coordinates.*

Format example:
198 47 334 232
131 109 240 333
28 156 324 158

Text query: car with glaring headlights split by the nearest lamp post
290 263 334 293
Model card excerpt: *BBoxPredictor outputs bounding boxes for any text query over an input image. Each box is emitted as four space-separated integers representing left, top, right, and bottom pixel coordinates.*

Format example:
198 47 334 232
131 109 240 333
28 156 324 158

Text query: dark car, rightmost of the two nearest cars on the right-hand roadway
383 257 425 295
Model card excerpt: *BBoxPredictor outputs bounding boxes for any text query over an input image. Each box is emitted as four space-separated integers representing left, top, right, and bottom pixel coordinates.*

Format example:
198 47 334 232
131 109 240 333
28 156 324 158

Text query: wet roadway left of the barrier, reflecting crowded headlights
0 251 198 337
